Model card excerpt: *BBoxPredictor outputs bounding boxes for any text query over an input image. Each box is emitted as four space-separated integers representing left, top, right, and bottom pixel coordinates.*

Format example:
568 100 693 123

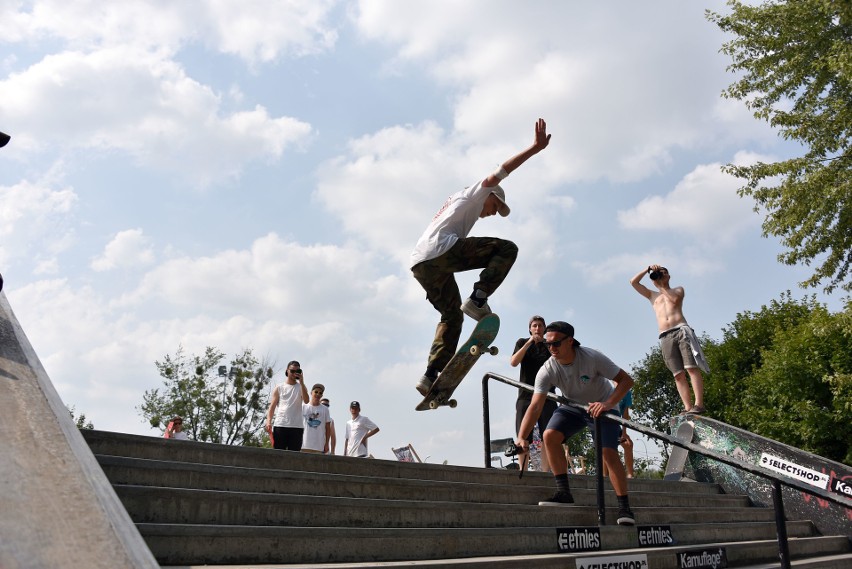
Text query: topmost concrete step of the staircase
82 430 720 494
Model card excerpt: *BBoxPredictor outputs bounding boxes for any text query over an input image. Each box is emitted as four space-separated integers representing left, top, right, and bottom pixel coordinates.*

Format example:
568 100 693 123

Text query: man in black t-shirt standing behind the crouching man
509 315 556 472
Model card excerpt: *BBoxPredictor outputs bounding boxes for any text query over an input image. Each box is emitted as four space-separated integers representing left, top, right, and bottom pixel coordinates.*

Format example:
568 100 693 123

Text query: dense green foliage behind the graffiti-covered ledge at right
704 291 852 464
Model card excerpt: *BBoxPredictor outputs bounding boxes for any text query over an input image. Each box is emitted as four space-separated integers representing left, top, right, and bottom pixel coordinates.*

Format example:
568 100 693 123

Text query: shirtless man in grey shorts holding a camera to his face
630 265 710 414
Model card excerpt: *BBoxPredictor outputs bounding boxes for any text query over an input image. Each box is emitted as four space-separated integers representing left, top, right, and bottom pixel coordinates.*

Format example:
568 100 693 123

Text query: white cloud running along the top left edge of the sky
0 0 337 62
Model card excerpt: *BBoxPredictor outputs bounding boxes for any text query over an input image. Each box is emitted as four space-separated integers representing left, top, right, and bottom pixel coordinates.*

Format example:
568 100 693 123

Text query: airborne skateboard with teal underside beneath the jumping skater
415 314 500 411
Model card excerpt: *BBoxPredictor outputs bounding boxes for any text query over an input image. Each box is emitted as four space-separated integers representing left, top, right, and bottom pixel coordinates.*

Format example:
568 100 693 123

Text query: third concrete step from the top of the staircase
115 485 775 528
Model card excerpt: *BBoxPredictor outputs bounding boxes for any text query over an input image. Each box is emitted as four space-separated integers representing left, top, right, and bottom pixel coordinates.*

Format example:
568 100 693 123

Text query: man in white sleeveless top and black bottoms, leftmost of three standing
266 360 310 451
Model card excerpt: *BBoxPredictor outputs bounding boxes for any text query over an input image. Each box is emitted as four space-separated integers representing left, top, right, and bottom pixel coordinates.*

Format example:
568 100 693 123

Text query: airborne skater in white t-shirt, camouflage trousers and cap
411 119 550 395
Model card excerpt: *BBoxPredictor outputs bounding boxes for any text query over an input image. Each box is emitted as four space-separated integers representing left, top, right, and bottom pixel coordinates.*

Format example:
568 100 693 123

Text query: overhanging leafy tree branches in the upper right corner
706 0 852 292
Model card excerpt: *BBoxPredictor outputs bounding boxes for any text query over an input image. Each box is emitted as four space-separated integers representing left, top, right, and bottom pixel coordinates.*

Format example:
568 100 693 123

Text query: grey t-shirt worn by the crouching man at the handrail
535 346 621 404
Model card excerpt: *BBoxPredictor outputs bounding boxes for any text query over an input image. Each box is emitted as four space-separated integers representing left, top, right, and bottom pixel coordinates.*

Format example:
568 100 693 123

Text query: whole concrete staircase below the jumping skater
83 431 852 568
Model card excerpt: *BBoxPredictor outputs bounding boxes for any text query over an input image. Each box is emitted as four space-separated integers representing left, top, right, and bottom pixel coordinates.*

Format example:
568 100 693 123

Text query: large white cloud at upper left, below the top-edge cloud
0 48 311 186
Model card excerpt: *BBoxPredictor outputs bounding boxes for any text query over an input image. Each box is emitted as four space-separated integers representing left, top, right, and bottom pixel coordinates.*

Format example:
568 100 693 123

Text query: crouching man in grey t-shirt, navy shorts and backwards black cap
515 321 636 525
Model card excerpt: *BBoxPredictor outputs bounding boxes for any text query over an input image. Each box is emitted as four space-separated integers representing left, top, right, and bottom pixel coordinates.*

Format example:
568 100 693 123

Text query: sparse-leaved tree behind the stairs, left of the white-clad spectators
138 346 274 446
